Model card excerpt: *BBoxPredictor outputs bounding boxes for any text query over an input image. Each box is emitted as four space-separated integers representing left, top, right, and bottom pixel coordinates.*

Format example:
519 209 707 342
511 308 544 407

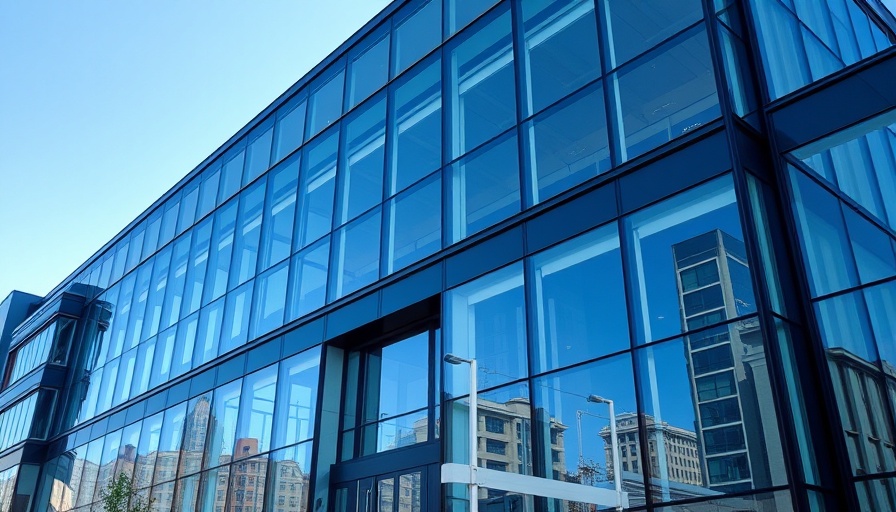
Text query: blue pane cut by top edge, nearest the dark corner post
601 0 703 68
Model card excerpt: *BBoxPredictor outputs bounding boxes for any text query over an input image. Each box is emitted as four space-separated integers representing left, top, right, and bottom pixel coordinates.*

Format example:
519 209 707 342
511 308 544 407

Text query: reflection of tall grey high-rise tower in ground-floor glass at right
668 230 780 492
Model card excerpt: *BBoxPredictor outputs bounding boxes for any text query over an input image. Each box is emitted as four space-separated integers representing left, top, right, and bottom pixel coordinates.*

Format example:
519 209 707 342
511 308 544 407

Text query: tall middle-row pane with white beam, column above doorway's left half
338 95 386 224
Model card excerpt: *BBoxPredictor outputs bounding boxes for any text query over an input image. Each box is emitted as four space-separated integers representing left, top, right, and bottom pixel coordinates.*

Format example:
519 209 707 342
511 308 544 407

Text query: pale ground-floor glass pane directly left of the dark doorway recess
273 349 320 448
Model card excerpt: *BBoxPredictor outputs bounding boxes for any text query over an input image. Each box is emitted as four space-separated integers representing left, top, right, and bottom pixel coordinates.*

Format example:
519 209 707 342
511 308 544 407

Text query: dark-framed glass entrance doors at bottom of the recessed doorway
333 467 427 512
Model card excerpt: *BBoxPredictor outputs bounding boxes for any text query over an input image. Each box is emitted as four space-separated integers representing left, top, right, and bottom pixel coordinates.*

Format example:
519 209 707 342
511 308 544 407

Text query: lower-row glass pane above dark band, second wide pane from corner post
523 86 610 204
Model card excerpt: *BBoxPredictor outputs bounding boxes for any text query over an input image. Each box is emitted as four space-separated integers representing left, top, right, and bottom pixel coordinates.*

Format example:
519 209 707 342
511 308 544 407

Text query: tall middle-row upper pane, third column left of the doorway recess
228 178 266 289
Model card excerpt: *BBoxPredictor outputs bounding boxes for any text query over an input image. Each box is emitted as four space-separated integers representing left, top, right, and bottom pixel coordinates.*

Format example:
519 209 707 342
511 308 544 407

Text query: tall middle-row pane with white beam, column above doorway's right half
389 56 442 194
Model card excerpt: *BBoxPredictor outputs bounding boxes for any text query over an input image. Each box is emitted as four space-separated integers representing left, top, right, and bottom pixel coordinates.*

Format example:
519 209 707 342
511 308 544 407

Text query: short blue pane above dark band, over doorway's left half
330 208 382 300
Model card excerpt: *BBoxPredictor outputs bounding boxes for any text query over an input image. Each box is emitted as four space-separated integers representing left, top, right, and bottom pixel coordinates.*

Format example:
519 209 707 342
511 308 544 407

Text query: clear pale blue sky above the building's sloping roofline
0 0 389 300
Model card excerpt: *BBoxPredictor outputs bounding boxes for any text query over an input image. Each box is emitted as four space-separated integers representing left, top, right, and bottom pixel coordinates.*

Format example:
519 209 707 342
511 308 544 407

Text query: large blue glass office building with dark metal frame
0 0 896 512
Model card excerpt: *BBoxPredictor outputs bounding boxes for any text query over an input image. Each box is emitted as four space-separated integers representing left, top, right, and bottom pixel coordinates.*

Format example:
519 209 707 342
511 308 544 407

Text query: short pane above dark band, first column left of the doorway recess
287 237 330 320
